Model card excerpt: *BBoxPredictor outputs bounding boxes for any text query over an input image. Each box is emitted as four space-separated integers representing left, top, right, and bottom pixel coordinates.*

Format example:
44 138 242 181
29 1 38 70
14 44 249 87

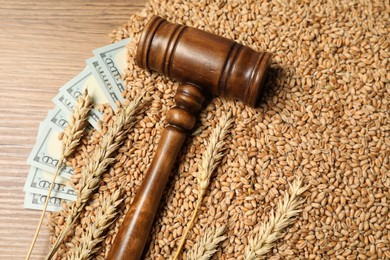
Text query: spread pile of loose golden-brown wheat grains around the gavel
49 0 390 259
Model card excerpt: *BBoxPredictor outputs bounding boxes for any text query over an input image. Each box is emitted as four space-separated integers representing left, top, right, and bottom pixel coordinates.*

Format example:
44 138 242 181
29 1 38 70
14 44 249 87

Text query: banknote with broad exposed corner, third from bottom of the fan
27 122 73 179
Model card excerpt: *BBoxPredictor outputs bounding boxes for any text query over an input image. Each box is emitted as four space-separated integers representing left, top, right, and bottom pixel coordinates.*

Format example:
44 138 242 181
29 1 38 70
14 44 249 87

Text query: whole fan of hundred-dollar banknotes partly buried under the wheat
24 39 130 211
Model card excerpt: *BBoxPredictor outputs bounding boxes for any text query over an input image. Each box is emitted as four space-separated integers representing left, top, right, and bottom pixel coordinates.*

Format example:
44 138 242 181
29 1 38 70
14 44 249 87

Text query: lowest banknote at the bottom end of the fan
24 193 69 211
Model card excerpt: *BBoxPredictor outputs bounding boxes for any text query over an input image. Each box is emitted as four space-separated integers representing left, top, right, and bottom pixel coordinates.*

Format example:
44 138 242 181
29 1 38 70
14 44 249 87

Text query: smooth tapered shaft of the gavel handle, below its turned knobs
107 126 186 260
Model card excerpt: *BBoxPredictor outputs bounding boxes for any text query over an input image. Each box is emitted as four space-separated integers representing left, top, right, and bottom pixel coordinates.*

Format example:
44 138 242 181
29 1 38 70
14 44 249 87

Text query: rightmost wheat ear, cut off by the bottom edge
245 179 307 260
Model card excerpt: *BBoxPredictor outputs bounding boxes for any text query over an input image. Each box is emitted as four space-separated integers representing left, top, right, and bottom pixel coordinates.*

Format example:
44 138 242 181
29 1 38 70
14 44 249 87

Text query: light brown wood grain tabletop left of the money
0 0 146 259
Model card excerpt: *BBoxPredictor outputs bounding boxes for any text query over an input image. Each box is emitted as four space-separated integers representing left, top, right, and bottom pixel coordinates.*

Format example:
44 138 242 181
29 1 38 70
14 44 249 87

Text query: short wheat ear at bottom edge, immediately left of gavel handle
68 190 122 260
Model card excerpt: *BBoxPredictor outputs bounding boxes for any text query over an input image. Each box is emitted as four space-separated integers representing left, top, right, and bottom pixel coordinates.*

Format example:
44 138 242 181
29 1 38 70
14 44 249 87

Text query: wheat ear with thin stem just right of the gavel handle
173 111 233 260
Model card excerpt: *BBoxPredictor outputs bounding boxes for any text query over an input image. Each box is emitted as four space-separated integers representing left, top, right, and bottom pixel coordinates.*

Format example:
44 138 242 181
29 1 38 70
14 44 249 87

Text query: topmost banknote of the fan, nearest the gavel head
93 38 131 93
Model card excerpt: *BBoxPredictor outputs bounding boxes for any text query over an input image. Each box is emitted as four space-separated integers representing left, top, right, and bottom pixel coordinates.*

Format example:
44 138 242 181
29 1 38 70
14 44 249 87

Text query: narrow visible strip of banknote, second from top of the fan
86 57 124 110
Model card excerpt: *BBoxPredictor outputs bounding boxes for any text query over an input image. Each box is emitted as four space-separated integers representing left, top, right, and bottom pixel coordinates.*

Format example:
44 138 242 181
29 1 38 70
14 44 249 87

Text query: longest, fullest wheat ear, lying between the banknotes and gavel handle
46 92 145 259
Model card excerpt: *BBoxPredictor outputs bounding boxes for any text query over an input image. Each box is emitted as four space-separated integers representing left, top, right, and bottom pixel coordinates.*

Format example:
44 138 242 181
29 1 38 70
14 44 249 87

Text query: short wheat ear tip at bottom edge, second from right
186 227 227 260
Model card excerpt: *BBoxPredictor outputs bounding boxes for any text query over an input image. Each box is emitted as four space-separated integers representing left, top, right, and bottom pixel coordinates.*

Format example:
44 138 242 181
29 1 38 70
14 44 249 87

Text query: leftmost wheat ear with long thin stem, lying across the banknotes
26 90 92 260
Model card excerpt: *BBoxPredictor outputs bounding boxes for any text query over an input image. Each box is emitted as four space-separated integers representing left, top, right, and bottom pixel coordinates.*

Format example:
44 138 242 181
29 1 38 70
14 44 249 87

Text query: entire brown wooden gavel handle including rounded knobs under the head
107 85 204 260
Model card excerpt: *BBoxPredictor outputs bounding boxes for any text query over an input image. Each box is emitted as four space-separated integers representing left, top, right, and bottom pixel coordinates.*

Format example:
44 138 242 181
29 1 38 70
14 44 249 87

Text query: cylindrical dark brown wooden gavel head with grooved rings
136 16 271 107
